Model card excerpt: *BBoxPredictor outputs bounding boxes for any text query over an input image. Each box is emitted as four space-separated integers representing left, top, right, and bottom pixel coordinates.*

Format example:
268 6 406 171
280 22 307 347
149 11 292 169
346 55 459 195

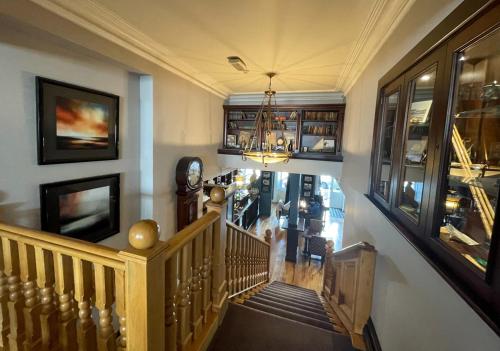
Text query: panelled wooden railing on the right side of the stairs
322 242 377 350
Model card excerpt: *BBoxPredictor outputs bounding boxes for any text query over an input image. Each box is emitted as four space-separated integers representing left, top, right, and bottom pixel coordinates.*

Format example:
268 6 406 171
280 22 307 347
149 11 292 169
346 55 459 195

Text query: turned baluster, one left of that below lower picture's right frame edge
73 258 97 350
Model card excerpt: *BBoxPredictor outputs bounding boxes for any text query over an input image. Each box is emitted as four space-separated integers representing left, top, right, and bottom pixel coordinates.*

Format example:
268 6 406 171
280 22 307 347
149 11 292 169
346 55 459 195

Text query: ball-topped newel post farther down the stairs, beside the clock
207 187 228 312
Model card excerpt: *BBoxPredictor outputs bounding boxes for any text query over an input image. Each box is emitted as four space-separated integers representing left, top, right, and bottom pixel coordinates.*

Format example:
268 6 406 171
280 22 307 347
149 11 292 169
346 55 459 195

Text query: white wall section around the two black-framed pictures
0 24 139 248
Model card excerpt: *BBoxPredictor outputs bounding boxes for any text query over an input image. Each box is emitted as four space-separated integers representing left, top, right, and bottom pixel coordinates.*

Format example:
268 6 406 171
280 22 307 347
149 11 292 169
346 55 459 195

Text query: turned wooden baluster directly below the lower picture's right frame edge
94 263 116 350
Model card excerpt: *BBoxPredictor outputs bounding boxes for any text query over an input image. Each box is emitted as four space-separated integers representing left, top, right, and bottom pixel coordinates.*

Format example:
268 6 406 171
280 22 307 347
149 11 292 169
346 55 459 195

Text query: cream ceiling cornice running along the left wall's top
30 0 229 98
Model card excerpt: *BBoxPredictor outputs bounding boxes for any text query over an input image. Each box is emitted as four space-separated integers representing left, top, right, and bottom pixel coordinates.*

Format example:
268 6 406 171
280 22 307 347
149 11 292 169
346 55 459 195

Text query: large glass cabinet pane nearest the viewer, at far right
439 29 500 272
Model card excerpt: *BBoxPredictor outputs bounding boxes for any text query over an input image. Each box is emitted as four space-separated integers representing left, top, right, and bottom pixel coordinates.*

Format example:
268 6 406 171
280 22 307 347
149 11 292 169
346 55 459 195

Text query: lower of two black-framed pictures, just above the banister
40 174 120 242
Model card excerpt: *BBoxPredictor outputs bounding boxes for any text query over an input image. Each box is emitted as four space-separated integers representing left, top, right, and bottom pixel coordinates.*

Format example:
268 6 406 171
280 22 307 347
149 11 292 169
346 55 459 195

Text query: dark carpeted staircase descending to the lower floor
209 281 354 351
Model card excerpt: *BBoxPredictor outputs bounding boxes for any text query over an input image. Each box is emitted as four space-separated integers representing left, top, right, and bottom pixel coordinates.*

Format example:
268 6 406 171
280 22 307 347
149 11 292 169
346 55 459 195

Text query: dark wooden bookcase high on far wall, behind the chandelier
219 104 345 161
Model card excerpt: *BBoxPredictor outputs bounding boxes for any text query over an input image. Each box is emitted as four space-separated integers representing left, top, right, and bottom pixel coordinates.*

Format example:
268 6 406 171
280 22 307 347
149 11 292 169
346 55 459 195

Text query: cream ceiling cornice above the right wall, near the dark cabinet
336 0 415 94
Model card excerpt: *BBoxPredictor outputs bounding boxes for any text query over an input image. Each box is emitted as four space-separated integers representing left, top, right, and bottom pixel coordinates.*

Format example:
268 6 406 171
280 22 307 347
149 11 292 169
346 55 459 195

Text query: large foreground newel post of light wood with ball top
119 220 166 351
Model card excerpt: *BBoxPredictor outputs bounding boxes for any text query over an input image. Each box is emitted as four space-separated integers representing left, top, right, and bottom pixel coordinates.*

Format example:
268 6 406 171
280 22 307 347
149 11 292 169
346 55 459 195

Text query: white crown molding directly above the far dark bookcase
225 91 345 105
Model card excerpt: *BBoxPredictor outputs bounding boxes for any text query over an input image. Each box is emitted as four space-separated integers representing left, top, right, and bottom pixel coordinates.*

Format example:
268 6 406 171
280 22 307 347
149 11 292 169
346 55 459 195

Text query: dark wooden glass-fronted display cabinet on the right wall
369 1 500 333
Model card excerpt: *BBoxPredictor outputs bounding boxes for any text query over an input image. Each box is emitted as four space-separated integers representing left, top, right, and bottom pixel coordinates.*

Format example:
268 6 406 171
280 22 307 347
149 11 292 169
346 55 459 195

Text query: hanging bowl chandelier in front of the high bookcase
243 72 291 166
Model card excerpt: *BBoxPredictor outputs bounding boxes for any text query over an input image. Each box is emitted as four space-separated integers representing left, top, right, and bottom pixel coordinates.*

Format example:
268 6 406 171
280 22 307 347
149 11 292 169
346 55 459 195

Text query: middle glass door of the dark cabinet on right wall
397 66 437 223
